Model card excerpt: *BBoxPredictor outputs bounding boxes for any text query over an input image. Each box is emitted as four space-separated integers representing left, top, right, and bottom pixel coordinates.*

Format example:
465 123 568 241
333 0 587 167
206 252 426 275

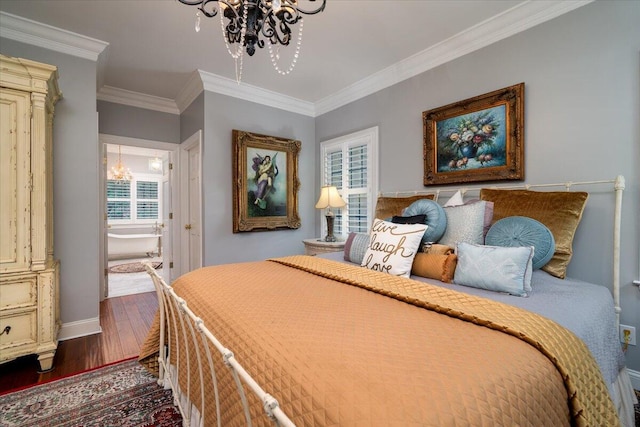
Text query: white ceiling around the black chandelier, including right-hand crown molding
0 0 589 114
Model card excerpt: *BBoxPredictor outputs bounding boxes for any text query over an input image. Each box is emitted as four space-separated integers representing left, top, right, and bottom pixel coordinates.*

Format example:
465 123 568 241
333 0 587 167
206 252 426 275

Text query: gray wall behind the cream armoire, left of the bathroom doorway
0 39 100 323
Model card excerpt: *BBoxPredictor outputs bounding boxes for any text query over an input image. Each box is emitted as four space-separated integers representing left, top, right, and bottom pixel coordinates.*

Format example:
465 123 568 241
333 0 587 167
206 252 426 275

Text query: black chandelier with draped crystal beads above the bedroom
179 0 327 84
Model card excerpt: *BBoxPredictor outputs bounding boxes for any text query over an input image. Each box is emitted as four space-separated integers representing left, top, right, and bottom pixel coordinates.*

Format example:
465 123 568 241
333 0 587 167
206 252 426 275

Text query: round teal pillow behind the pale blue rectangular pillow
484 216 556 270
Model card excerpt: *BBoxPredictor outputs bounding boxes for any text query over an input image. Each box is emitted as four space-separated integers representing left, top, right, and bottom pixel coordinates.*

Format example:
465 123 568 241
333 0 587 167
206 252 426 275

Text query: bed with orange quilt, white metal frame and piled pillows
140 177 635 426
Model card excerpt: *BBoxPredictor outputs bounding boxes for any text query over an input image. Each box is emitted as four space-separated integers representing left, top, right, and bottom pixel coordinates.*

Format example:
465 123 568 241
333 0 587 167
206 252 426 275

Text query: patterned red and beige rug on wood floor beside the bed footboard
0 360 182 427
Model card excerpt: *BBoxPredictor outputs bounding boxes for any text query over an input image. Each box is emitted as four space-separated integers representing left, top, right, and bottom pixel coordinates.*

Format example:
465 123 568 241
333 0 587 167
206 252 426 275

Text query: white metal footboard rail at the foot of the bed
145 263 295 426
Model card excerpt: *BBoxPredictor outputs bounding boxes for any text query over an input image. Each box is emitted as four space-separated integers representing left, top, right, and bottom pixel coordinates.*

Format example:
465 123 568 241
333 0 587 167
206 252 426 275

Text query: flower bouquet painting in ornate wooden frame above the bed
422 83 524 186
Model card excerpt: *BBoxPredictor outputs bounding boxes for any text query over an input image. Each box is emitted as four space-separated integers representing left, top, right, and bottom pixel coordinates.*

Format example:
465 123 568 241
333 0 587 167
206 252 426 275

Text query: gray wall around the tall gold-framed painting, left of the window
202 92 317 265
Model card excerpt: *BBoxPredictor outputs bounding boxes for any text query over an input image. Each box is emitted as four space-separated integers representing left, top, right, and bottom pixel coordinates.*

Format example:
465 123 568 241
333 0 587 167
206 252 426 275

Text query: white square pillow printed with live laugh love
361 218 427 277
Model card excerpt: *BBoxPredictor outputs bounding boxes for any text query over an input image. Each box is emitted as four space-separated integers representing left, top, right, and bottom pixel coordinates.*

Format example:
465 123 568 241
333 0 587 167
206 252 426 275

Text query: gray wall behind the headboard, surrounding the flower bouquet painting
316 1 640 371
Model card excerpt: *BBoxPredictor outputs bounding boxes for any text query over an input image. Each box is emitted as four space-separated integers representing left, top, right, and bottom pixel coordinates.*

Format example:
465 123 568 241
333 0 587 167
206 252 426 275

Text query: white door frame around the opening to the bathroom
98 133 180 301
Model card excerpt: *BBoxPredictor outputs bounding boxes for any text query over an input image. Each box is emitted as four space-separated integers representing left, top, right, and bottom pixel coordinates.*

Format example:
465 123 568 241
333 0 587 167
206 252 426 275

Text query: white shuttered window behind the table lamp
320 127 378 237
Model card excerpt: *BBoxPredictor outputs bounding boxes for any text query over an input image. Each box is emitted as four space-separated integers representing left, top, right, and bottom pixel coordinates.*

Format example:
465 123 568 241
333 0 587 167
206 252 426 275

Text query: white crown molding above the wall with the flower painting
315 0 594 116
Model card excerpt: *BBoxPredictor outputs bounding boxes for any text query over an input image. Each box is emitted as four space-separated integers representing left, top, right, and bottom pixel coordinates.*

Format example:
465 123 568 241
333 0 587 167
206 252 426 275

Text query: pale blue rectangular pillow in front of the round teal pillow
453 242 534 297
